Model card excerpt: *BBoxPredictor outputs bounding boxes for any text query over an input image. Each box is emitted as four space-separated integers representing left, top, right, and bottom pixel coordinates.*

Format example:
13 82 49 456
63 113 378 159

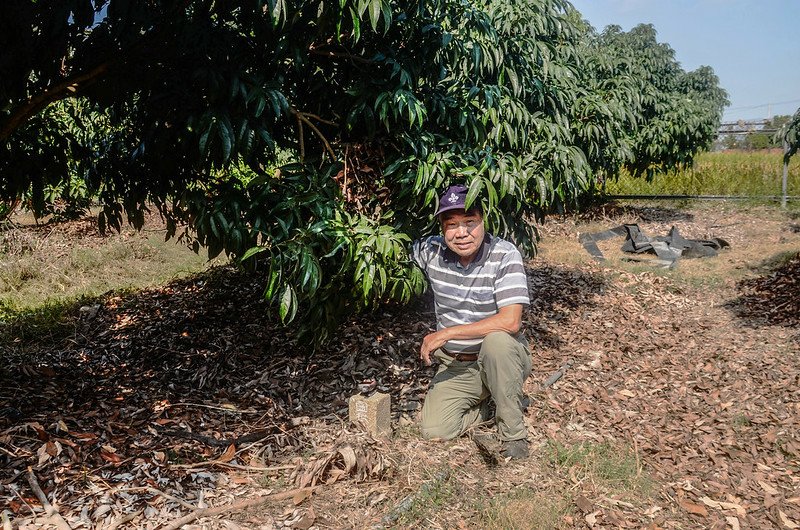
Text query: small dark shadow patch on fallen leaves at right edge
725 252 800 328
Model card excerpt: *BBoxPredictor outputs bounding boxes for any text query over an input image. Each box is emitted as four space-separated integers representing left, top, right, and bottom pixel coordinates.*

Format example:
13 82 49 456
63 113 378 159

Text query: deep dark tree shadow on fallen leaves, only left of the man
0 268 432 428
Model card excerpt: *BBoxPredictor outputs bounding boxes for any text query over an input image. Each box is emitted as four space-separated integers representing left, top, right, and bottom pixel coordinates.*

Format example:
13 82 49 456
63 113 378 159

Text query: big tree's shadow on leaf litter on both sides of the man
0 258 605 480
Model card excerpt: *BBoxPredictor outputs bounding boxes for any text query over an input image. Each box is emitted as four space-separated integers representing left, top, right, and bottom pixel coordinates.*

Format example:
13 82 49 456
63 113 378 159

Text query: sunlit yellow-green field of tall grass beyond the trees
606 151 800 196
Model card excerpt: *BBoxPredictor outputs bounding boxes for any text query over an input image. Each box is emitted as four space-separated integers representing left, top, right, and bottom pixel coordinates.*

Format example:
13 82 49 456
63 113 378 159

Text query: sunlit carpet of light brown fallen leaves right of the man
533 260 800 528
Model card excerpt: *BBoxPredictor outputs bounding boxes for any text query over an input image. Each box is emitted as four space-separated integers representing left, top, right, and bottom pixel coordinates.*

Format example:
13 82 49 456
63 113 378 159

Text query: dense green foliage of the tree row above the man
0 0 726 337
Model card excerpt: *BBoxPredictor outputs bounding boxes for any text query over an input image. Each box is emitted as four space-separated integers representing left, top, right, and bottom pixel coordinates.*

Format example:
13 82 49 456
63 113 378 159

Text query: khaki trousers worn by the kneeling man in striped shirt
420 332 531 441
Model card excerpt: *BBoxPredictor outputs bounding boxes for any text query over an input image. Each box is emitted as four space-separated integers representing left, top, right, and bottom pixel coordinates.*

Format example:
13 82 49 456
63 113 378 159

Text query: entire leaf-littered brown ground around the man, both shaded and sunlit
0 200 800 528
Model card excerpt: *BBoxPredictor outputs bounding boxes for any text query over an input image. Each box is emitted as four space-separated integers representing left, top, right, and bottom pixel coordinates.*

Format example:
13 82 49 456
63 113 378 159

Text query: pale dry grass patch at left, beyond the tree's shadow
0 214 216 318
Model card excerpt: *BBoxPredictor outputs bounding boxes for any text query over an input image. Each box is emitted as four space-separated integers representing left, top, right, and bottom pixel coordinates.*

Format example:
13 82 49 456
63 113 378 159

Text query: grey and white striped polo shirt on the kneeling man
412 234 530 353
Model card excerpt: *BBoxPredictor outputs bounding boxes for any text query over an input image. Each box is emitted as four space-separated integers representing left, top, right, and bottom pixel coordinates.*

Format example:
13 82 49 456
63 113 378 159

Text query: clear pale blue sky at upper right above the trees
571 0 800 121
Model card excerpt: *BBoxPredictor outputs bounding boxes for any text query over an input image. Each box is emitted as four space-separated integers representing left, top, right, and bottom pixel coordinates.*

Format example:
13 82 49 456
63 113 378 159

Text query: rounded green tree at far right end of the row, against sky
573 24 728 183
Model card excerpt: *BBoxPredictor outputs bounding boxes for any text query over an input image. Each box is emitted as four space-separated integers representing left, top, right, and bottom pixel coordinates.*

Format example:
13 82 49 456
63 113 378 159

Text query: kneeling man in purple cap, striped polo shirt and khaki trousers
413 185 531 458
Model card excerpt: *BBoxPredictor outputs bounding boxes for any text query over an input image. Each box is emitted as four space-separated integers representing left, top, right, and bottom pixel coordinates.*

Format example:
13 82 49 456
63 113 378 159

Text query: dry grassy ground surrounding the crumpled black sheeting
540 202 800 291
